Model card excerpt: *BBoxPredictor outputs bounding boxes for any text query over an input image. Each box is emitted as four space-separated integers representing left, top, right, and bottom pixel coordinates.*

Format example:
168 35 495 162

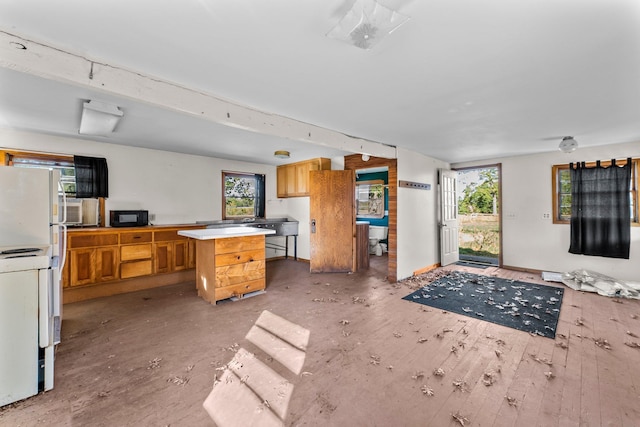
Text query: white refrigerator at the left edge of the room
0 166 66 406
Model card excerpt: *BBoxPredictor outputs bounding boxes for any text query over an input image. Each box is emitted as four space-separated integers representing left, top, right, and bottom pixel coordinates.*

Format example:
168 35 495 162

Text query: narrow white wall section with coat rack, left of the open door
397 148 449 280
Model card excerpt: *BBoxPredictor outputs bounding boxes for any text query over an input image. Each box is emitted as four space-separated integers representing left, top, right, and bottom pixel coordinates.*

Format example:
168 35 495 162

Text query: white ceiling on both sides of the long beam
0 0 640 164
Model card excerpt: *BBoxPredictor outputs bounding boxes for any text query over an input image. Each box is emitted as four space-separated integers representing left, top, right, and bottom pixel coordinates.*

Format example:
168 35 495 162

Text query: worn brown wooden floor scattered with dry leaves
0 257 640 426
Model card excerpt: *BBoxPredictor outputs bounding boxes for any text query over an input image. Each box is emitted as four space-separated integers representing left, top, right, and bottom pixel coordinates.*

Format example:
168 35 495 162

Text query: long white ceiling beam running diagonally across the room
0 30 396 158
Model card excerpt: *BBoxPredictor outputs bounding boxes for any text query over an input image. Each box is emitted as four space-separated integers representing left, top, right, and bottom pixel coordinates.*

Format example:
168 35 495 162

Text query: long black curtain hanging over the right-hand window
569 159 631 259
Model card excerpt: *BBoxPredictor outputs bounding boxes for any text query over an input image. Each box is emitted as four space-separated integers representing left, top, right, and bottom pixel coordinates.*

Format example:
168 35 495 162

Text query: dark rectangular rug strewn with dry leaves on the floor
402 271 564 338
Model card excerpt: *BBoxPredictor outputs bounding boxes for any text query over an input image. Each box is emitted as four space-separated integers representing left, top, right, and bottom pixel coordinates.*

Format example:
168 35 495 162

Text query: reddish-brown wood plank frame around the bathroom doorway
344 154 398 283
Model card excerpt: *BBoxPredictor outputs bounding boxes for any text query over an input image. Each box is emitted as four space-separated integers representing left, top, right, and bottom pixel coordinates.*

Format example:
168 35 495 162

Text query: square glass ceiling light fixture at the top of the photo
327 0 409 50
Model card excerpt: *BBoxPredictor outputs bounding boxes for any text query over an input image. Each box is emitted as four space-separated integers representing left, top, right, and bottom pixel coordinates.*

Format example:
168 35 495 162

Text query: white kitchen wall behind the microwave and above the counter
0 129 290 257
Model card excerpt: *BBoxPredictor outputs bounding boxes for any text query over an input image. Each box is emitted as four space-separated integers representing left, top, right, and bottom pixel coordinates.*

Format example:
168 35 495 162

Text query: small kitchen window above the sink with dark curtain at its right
222 171 265 219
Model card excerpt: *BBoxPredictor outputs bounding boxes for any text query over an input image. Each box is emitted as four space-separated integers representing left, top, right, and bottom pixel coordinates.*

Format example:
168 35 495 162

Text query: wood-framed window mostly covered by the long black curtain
551 159 640 226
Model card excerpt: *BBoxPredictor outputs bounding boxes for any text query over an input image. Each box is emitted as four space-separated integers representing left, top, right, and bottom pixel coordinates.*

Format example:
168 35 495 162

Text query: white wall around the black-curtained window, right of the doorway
451 143 640 281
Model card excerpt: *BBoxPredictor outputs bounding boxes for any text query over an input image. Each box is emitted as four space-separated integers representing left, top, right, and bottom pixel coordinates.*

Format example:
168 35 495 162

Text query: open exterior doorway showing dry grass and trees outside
457 164 502 267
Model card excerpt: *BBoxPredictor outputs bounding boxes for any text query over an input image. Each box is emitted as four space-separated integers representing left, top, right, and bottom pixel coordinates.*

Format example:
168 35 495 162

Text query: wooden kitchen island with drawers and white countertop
178 227 275 304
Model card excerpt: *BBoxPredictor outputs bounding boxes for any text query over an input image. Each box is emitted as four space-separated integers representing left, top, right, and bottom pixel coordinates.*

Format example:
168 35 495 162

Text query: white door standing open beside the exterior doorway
439 169 460 266
